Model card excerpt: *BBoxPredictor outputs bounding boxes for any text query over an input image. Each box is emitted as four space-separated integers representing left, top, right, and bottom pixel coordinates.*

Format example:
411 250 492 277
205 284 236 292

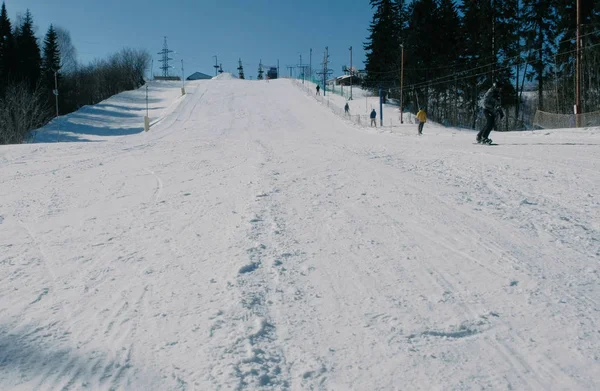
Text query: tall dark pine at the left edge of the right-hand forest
364 0 404 89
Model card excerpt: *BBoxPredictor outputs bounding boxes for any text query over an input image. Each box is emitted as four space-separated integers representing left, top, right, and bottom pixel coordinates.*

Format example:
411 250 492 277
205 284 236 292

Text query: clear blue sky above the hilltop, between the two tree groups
0 0 373 79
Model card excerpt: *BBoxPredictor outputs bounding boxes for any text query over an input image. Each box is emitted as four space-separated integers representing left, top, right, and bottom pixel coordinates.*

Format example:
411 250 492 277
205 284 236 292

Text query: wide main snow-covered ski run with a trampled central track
0 80 600 390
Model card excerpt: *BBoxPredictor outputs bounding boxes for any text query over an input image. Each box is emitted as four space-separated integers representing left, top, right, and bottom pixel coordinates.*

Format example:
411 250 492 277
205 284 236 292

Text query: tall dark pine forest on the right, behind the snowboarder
364 0 600 129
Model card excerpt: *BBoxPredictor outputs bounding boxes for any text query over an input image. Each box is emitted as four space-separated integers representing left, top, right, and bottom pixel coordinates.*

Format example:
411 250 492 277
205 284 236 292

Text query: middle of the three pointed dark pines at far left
15 10 42 90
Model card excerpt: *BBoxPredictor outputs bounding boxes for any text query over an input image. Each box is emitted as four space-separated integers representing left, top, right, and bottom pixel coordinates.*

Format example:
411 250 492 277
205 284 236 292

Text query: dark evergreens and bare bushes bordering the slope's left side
0 3 151 144
